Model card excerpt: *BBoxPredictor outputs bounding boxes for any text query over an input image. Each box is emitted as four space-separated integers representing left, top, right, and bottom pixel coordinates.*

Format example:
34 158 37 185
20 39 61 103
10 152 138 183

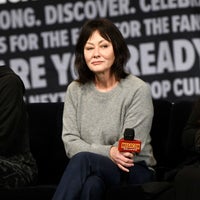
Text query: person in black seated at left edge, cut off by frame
0 66 37 188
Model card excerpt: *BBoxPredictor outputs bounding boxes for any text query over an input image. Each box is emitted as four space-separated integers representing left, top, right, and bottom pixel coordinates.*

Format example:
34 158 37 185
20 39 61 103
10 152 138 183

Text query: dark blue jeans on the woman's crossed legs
53 152 154 200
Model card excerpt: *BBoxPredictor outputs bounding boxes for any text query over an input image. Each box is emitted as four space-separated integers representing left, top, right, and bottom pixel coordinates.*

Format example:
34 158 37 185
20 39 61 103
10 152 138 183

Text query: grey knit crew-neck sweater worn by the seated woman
62 75 156 166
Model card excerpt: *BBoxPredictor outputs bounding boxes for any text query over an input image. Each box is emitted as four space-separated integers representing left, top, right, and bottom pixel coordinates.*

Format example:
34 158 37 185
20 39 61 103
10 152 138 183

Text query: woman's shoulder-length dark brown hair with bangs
75 19 130 84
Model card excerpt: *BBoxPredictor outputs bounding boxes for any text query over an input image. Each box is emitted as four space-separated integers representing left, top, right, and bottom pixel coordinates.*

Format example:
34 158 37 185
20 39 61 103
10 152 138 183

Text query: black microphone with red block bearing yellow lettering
118 128 141 153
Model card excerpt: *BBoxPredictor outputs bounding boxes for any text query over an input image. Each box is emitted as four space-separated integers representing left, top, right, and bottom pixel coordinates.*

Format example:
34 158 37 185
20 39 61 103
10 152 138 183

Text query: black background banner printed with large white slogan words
0 0 200 103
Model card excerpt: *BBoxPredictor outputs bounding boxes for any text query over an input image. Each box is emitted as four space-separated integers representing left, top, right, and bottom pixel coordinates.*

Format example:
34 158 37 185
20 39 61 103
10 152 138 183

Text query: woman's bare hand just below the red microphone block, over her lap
110 147 134 172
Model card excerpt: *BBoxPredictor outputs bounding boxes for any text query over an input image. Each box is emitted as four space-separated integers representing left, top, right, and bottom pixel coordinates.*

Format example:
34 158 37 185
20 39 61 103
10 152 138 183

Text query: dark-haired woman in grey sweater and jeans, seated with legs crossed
53 19 156 200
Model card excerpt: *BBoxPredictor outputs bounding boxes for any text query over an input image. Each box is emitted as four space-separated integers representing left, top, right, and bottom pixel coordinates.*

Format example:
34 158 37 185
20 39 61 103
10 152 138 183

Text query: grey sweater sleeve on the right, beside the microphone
124 84 156 166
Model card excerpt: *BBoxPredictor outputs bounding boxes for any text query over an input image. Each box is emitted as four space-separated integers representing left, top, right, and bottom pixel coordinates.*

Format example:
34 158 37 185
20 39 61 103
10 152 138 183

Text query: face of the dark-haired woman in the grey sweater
84 31 115 74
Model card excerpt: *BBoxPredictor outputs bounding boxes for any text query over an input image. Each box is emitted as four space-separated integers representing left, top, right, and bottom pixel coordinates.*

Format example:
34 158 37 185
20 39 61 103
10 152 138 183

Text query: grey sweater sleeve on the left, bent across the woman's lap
62 83 111 158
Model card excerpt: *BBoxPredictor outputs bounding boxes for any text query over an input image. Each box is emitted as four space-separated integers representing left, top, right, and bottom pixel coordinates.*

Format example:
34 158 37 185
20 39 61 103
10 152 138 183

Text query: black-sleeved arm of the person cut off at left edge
0 73 26 155
